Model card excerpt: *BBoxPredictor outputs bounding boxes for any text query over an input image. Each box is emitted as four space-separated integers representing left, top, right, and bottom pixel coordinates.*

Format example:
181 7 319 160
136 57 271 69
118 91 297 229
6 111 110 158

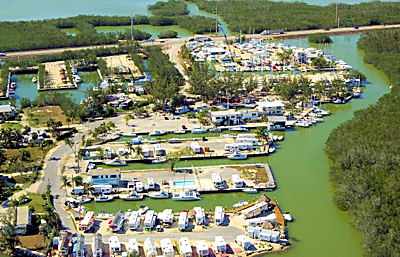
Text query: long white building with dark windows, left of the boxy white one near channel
211 110 258 125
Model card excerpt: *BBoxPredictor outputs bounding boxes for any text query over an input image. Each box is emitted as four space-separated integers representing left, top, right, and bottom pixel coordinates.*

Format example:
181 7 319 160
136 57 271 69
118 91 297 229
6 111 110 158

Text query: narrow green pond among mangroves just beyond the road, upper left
96 25 193 39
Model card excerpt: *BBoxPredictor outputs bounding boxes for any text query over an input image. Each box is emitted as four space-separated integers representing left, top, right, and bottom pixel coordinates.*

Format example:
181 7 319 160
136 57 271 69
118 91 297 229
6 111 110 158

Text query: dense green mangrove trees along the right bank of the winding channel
326 30 400 257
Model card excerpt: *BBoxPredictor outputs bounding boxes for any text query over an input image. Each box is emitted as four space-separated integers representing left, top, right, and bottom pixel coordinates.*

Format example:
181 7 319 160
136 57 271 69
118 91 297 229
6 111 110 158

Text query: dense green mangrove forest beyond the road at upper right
189 0 400 33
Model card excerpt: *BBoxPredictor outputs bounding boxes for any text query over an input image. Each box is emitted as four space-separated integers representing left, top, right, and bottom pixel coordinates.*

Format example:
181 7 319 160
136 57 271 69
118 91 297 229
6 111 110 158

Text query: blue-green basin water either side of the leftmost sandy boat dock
11 72 99 103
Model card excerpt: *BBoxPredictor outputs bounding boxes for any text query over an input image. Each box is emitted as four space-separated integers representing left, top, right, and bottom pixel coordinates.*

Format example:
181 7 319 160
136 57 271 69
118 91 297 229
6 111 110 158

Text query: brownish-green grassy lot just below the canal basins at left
24 106 67 127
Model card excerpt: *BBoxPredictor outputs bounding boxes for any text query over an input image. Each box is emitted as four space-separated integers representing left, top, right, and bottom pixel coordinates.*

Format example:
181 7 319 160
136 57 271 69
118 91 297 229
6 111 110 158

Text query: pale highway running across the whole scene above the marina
0 24 400 59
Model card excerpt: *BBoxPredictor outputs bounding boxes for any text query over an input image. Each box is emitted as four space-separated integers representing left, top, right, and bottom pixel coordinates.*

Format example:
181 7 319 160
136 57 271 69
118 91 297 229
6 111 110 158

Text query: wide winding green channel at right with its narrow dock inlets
83 35 388 257
